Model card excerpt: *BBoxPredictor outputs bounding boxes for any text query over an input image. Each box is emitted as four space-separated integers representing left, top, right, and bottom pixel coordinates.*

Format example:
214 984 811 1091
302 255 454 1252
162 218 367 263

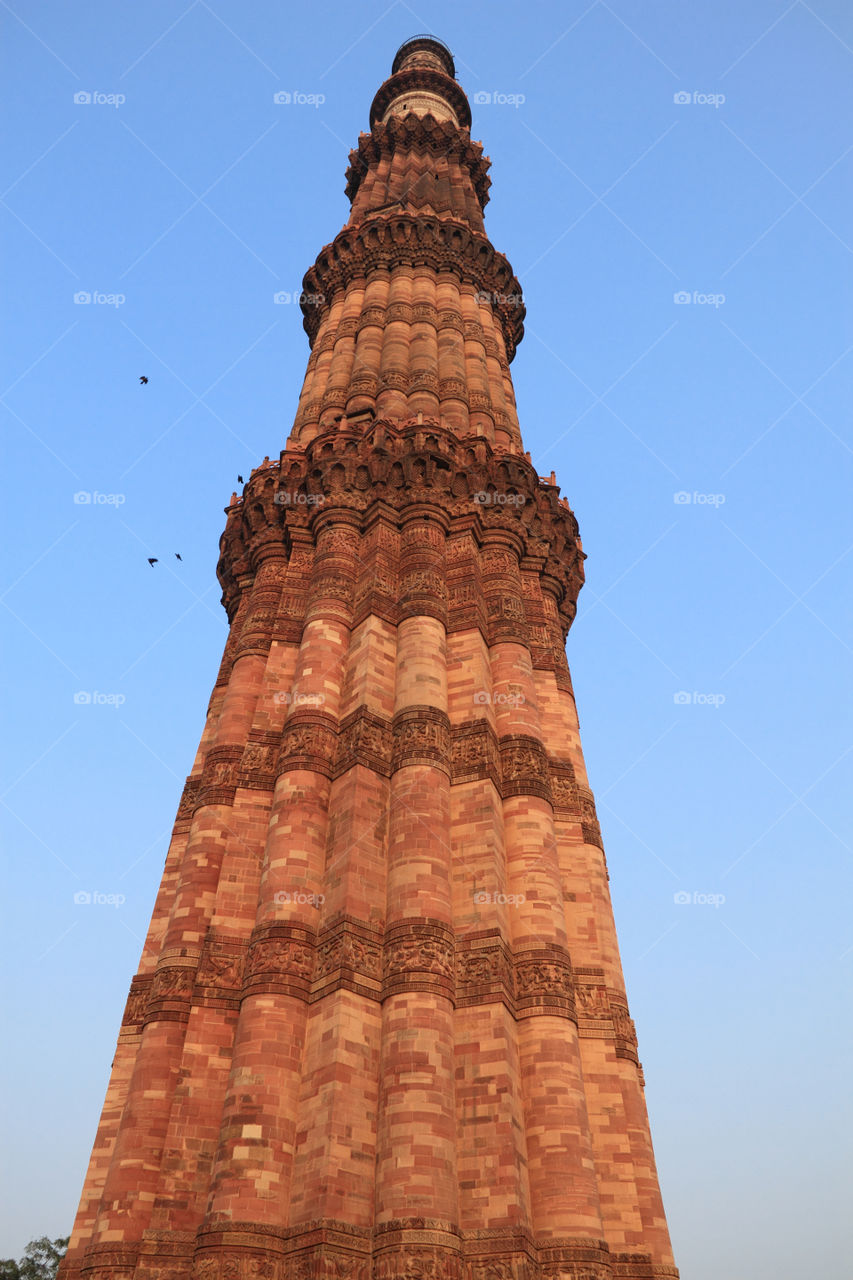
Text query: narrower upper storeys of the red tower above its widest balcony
291 36 524 453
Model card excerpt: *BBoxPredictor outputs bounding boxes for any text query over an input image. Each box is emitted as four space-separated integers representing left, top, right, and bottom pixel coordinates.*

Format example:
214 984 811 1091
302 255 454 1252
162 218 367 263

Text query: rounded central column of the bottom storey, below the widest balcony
377 515 457 1252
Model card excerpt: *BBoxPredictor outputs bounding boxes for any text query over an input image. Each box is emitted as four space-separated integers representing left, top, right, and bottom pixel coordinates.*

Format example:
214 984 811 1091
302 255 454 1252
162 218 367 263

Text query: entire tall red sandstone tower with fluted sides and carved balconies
63 36 678 1280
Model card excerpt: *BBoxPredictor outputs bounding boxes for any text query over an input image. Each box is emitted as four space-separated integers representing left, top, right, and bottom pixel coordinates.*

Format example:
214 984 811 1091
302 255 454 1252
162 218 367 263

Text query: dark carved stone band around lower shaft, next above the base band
123 918 638 1062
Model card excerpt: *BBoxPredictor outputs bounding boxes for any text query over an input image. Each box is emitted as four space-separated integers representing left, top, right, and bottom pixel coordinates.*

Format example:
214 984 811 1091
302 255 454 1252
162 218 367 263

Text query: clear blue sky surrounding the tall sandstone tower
0 0 853 1280
